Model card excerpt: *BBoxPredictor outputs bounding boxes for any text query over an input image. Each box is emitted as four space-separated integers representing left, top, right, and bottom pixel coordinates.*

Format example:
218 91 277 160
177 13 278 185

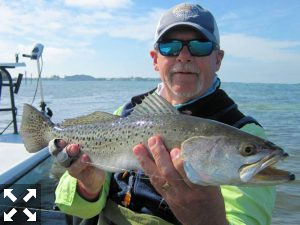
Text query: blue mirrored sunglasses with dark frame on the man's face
156 40 216 57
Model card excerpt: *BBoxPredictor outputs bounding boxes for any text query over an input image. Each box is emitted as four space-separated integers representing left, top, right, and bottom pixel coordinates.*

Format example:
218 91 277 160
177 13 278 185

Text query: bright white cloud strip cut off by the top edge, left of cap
65 0 132 9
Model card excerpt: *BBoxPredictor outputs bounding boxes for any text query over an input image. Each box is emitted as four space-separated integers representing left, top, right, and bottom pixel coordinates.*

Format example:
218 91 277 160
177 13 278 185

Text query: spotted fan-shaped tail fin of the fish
20 104 54 153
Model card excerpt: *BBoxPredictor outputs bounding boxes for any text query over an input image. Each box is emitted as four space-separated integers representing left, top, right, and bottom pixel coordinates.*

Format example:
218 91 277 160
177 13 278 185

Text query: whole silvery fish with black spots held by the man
20 94 295 185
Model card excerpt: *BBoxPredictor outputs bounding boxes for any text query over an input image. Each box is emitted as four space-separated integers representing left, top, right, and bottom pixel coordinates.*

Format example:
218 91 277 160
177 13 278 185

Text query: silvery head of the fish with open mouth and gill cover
181 134 295 186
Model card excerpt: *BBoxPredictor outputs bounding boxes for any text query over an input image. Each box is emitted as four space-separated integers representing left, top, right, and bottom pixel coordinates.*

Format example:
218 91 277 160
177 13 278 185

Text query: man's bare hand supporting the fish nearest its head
133 136 228 225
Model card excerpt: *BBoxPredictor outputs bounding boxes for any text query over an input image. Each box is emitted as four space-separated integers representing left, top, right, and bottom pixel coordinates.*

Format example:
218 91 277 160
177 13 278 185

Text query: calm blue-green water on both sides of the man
0 81 300 225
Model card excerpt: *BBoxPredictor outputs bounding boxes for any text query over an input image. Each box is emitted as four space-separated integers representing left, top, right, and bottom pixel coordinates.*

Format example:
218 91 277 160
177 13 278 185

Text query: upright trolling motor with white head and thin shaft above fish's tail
22 43 53 117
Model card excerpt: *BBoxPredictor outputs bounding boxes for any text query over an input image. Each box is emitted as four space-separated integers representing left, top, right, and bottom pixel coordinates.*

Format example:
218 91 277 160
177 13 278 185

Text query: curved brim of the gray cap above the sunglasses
154 22 218 44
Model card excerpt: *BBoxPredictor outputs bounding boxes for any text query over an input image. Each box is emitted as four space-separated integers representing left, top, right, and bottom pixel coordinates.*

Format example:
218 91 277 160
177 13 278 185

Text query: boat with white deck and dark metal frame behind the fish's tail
0 45 72 225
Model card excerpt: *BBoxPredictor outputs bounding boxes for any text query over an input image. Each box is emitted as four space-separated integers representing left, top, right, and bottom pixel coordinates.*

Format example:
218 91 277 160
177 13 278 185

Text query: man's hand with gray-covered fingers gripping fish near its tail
49 139 105 200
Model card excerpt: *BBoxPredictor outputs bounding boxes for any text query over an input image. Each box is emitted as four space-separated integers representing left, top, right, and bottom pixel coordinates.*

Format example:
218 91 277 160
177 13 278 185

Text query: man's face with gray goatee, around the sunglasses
150 29 224 101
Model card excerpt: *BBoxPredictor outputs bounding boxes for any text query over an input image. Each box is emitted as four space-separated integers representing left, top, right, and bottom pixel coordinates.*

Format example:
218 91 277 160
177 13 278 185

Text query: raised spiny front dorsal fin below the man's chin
131 92 180 116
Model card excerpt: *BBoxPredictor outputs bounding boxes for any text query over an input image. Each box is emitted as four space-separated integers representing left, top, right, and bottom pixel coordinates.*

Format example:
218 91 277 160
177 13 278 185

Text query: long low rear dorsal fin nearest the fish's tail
60 111 120 127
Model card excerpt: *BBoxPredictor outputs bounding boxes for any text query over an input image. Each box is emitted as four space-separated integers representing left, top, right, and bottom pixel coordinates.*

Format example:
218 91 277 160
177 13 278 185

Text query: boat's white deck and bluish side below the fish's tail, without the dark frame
0 133 72 225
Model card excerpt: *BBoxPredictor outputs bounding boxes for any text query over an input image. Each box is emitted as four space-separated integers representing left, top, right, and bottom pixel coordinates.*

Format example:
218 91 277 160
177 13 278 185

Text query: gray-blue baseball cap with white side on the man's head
154 3 220 45
